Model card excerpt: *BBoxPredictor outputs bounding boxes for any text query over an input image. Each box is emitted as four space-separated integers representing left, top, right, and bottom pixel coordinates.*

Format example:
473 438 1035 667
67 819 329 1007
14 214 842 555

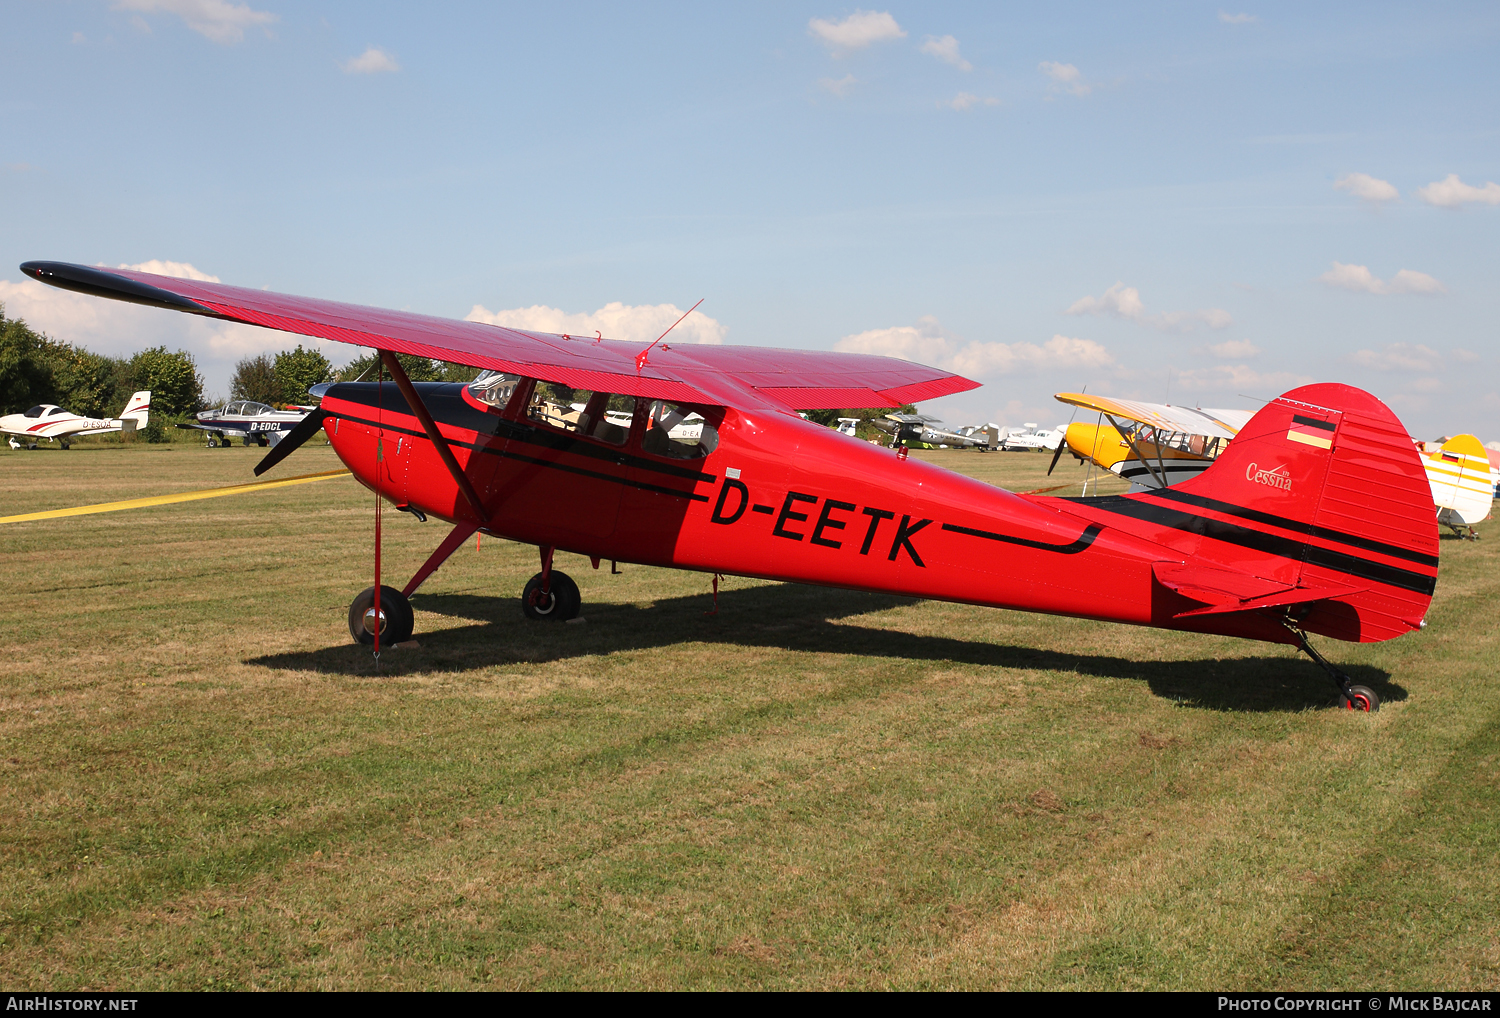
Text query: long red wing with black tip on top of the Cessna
21 262 978 409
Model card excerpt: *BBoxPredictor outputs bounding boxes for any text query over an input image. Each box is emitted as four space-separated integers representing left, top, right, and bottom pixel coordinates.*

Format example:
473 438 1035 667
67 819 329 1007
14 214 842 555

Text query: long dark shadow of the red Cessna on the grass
246 583 1407 712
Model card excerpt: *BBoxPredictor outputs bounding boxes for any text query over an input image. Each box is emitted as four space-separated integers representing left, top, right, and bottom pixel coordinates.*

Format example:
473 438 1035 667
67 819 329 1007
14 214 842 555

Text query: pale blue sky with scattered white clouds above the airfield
0 0 1500 441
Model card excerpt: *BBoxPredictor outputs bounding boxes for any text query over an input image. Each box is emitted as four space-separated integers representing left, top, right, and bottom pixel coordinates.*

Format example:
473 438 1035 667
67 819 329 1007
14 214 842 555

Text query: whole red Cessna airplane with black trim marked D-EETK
21 262 1439 711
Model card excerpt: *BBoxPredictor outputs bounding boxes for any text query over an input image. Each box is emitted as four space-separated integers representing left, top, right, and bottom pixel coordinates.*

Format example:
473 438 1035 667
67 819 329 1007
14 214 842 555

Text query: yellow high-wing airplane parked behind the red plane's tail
1047 393 1254 492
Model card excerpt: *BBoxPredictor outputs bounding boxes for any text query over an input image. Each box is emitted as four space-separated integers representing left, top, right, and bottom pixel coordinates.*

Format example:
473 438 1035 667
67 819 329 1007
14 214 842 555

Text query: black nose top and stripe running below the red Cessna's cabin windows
333 382 719 484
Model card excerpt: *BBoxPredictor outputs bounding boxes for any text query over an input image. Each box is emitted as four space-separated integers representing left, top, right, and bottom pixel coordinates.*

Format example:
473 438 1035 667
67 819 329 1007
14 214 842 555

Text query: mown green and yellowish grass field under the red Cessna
0 444 1500 990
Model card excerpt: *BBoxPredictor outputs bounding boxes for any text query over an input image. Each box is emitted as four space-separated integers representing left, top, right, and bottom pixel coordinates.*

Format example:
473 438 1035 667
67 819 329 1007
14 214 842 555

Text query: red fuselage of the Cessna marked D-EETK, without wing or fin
323 382 1430 642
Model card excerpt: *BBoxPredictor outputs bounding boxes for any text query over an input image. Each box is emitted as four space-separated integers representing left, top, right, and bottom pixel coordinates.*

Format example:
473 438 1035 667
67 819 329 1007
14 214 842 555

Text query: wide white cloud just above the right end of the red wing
834 315 1115 378
